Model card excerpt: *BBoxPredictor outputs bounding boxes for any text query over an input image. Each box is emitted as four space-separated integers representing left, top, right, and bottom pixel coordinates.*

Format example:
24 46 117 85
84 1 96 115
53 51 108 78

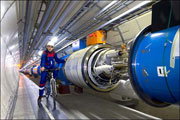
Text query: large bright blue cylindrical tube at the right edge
129 25 180 107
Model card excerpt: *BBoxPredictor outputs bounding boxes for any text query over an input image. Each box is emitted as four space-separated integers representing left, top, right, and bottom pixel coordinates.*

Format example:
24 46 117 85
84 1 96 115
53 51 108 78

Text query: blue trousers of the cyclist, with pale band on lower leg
39 70 58 96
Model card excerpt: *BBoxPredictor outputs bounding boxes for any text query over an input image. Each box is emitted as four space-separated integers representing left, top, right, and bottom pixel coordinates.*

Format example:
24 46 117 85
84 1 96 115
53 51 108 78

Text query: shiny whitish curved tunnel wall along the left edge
1 1 19 119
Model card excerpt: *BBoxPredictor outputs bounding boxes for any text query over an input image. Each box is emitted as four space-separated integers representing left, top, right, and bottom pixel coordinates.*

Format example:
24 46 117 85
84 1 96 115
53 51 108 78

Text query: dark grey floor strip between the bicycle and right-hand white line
58 93 157 119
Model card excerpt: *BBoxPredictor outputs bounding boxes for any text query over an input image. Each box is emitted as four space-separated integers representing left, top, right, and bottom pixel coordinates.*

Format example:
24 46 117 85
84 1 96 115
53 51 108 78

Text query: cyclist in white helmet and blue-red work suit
38 41 65 102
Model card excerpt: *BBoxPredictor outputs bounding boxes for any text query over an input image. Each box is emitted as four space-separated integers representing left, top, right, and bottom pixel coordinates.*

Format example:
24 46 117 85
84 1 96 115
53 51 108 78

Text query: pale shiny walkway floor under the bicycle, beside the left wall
13 74 68 120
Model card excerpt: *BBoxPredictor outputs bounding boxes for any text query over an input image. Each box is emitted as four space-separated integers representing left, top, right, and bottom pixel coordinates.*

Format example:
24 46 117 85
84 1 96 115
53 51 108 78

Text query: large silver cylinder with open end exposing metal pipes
64 44 127 92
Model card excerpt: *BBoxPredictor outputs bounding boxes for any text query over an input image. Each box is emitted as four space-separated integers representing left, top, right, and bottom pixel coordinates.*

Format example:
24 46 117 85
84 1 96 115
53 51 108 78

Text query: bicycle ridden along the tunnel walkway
44 68 59 109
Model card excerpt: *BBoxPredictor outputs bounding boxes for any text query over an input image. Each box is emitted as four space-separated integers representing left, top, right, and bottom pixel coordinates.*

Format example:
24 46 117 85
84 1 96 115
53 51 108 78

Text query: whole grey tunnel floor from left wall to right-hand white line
13 74 161 119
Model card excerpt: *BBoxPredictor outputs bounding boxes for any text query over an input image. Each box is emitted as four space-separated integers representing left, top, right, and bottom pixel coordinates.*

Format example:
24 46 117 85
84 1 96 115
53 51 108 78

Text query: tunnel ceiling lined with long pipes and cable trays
6 0 155 68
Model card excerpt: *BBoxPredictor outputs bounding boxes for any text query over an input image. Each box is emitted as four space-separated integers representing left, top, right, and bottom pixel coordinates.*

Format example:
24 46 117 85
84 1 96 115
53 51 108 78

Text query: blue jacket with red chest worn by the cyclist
40 50 65 69
